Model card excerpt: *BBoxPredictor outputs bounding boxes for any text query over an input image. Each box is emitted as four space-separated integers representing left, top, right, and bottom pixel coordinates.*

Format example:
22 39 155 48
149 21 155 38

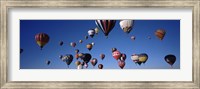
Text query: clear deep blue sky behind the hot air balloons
20 20 180 69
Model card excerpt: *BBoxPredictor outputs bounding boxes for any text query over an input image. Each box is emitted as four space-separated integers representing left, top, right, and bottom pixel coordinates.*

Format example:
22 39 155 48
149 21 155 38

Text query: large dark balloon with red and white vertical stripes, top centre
95 20 116 37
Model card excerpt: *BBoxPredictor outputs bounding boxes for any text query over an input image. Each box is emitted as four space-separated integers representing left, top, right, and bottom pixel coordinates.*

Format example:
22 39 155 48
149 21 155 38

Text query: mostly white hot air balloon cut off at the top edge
119 20 134 33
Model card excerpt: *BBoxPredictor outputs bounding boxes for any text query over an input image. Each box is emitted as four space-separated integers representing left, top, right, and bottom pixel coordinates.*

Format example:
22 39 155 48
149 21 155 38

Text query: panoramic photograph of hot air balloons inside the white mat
19 19 181 70
